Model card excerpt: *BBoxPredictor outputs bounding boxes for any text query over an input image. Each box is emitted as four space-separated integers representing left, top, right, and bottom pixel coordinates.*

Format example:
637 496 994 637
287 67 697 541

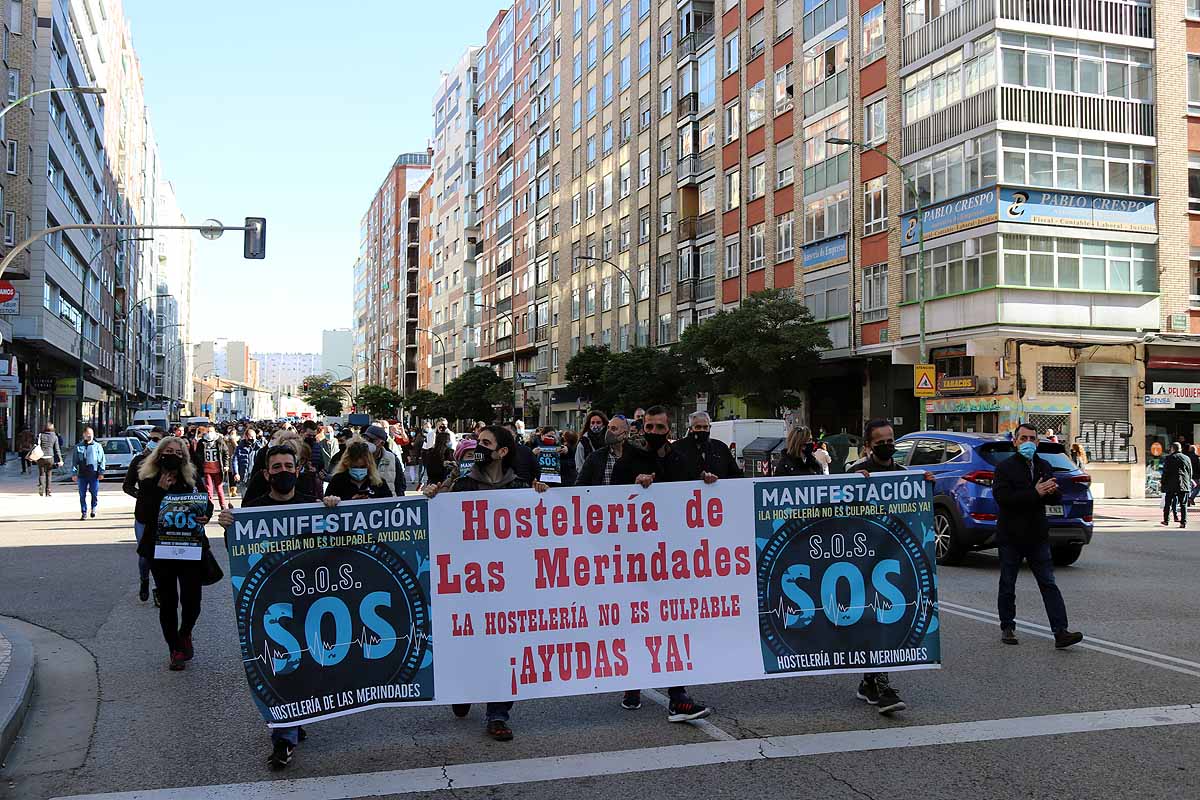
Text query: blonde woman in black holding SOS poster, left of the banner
133 437 212 672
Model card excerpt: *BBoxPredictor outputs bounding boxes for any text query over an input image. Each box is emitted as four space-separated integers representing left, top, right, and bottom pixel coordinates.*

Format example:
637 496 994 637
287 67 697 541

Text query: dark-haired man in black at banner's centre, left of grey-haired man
609 405 718 722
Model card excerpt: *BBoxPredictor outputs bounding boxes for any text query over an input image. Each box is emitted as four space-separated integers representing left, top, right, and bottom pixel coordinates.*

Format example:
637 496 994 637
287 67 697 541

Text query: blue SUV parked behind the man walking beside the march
895 431 1092 566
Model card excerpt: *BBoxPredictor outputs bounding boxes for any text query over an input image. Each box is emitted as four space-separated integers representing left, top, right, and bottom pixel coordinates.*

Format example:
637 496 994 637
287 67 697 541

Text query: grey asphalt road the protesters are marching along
0 487 1200 800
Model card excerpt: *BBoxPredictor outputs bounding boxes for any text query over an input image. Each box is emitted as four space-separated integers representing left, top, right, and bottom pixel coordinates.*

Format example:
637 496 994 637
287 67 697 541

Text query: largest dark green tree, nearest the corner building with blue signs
673 289 833 413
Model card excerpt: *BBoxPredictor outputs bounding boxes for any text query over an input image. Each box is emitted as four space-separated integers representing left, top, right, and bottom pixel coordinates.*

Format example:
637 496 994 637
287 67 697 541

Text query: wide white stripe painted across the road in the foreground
60 705 1200 800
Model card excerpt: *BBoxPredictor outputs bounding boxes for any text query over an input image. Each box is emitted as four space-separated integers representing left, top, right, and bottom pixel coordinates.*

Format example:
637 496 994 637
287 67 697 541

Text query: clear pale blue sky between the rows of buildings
124 0 508 353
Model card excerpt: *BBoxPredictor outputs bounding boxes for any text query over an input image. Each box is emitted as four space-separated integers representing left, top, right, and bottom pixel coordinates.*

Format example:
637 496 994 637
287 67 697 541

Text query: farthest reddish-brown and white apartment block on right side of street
354 151 432 393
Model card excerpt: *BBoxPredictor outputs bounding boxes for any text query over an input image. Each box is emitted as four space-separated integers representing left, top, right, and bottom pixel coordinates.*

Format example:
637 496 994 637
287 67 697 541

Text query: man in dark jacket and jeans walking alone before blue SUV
992 422 1084 649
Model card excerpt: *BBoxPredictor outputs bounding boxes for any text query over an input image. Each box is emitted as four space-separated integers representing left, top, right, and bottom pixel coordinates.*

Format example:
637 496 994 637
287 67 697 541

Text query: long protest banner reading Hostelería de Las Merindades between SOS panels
226 473 941 727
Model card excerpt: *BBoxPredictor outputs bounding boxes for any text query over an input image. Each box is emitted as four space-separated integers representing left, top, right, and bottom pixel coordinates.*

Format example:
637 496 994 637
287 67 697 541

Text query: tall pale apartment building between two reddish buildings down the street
418 47 481 391
